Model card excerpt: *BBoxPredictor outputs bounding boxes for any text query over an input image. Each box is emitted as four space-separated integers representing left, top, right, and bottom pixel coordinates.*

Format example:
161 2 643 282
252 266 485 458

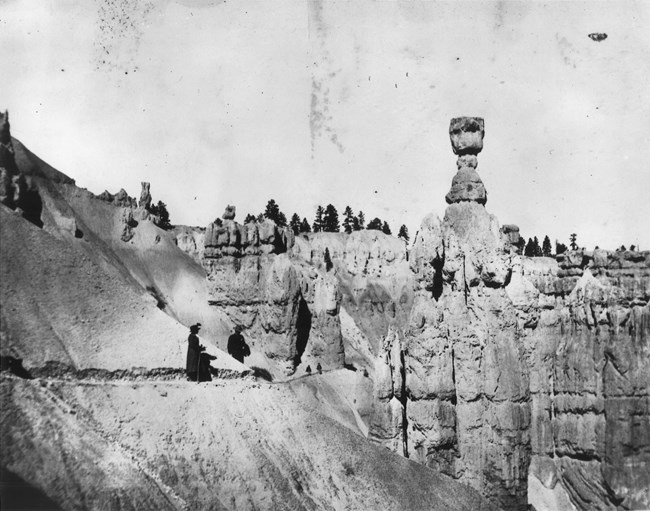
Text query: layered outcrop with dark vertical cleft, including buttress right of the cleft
201 210 345 376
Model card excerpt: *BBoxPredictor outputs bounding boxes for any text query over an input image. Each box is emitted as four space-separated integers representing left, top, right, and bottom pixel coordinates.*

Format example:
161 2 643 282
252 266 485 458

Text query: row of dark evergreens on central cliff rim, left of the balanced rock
244 199 409 242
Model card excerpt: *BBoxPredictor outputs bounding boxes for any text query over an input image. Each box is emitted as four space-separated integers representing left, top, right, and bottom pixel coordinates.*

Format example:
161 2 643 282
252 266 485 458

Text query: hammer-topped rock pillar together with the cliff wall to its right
370 118 650 510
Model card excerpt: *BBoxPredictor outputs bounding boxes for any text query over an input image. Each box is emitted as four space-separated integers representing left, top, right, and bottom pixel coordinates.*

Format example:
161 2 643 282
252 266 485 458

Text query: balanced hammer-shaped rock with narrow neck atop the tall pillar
445 117 487 204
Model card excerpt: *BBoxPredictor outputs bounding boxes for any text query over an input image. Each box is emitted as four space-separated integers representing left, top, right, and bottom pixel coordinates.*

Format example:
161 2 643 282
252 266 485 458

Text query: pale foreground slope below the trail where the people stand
2 378 490 511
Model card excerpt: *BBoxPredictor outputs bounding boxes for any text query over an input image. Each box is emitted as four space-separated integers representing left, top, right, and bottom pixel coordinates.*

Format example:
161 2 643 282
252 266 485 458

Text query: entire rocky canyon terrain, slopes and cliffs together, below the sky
0 110 650 511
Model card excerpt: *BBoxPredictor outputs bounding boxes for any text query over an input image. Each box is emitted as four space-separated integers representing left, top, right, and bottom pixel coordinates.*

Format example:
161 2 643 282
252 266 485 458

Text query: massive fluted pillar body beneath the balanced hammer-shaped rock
391 201 530 509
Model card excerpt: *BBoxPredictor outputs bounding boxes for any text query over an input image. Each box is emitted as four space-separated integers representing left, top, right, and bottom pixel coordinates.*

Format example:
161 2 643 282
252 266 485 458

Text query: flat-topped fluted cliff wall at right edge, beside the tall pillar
518 250 650 509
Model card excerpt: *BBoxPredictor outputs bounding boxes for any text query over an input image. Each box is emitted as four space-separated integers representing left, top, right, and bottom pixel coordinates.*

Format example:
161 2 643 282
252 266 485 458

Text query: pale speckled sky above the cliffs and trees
0 0 650 250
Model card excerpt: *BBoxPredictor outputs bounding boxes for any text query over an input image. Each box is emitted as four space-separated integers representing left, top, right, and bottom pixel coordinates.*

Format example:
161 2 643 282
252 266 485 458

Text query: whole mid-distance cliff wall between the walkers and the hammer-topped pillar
195 222 412 376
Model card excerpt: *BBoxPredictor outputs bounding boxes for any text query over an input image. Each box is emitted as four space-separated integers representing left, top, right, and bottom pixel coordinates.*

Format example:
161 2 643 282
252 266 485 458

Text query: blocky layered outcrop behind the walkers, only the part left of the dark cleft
201 219 312 374
